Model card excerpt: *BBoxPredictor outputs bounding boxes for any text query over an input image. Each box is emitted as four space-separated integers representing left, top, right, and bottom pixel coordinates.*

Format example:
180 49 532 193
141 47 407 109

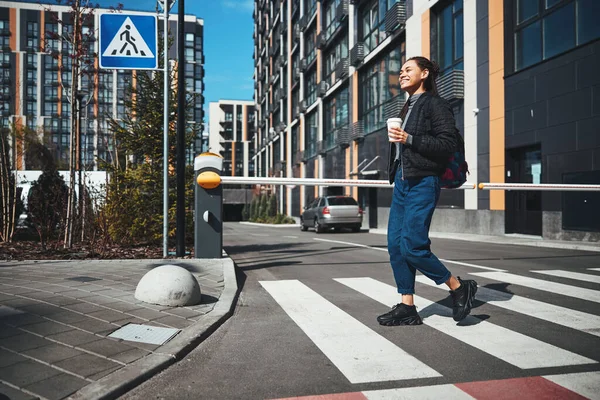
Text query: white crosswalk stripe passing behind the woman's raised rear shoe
416 275 600 336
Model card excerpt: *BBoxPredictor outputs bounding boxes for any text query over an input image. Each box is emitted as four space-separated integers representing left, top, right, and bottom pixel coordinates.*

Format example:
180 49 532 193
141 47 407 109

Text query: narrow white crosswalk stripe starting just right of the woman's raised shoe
470 272 600 303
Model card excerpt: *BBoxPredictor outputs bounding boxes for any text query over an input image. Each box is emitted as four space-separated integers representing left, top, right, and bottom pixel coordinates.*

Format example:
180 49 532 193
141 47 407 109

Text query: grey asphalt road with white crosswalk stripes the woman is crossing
122 223 600 399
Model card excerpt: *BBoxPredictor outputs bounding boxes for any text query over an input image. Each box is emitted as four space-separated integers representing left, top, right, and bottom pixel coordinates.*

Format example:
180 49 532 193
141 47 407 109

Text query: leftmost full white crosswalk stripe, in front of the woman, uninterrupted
260 280 441 383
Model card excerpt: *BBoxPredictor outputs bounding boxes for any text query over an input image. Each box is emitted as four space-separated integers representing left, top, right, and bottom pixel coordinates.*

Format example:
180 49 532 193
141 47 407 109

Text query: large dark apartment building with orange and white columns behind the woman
253 0 600 240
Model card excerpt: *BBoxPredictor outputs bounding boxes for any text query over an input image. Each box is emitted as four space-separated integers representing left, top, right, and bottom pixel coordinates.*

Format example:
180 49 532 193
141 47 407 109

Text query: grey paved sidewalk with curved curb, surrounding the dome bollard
0 258 238 400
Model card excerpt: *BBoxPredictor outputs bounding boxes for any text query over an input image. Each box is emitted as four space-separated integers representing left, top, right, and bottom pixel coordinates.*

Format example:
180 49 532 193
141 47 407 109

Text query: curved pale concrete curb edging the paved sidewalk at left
67 255 239 400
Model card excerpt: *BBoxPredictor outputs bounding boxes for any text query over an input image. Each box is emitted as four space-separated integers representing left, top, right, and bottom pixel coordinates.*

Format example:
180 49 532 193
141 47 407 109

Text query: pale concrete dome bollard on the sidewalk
135 265 202 307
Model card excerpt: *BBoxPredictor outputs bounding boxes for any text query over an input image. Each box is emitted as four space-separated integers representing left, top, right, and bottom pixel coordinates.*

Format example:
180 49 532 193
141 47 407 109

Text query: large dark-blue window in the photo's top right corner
514 0 600 71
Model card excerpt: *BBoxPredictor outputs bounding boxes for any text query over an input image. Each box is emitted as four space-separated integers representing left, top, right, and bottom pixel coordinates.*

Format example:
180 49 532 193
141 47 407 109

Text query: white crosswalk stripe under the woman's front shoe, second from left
336 278 596 369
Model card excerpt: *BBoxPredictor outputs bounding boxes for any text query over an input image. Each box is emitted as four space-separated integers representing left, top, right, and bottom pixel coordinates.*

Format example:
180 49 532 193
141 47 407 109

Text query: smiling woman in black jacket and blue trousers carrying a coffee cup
377 57 477 325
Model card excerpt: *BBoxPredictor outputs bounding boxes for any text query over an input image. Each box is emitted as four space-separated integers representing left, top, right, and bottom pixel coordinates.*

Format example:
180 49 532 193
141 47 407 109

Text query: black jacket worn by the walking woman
388 92 458 183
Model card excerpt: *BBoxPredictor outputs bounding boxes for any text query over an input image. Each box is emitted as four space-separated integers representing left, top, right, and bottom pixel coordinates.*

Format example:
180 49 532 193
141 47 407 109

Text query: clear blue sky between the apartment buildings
85 0 254 121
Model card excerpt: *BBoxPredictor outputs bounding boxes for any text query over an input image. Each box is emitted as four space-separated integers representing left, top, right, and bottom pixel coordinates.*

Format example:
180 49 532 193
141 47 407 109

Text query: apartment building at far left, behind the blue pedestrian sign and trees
0 1 204 171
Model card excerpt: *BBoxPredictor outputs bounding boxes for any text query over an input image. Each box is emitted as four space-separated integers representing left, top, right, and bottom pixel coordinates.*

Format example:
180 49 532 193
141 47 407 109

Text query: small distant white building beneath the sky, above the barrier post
208 100 255 176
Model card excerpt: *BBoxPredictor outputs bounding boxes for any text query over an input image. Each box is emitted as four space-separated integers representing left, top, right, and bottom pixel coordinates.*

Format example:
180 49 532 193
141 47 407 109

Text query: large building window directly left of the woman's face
359 49 404 134
